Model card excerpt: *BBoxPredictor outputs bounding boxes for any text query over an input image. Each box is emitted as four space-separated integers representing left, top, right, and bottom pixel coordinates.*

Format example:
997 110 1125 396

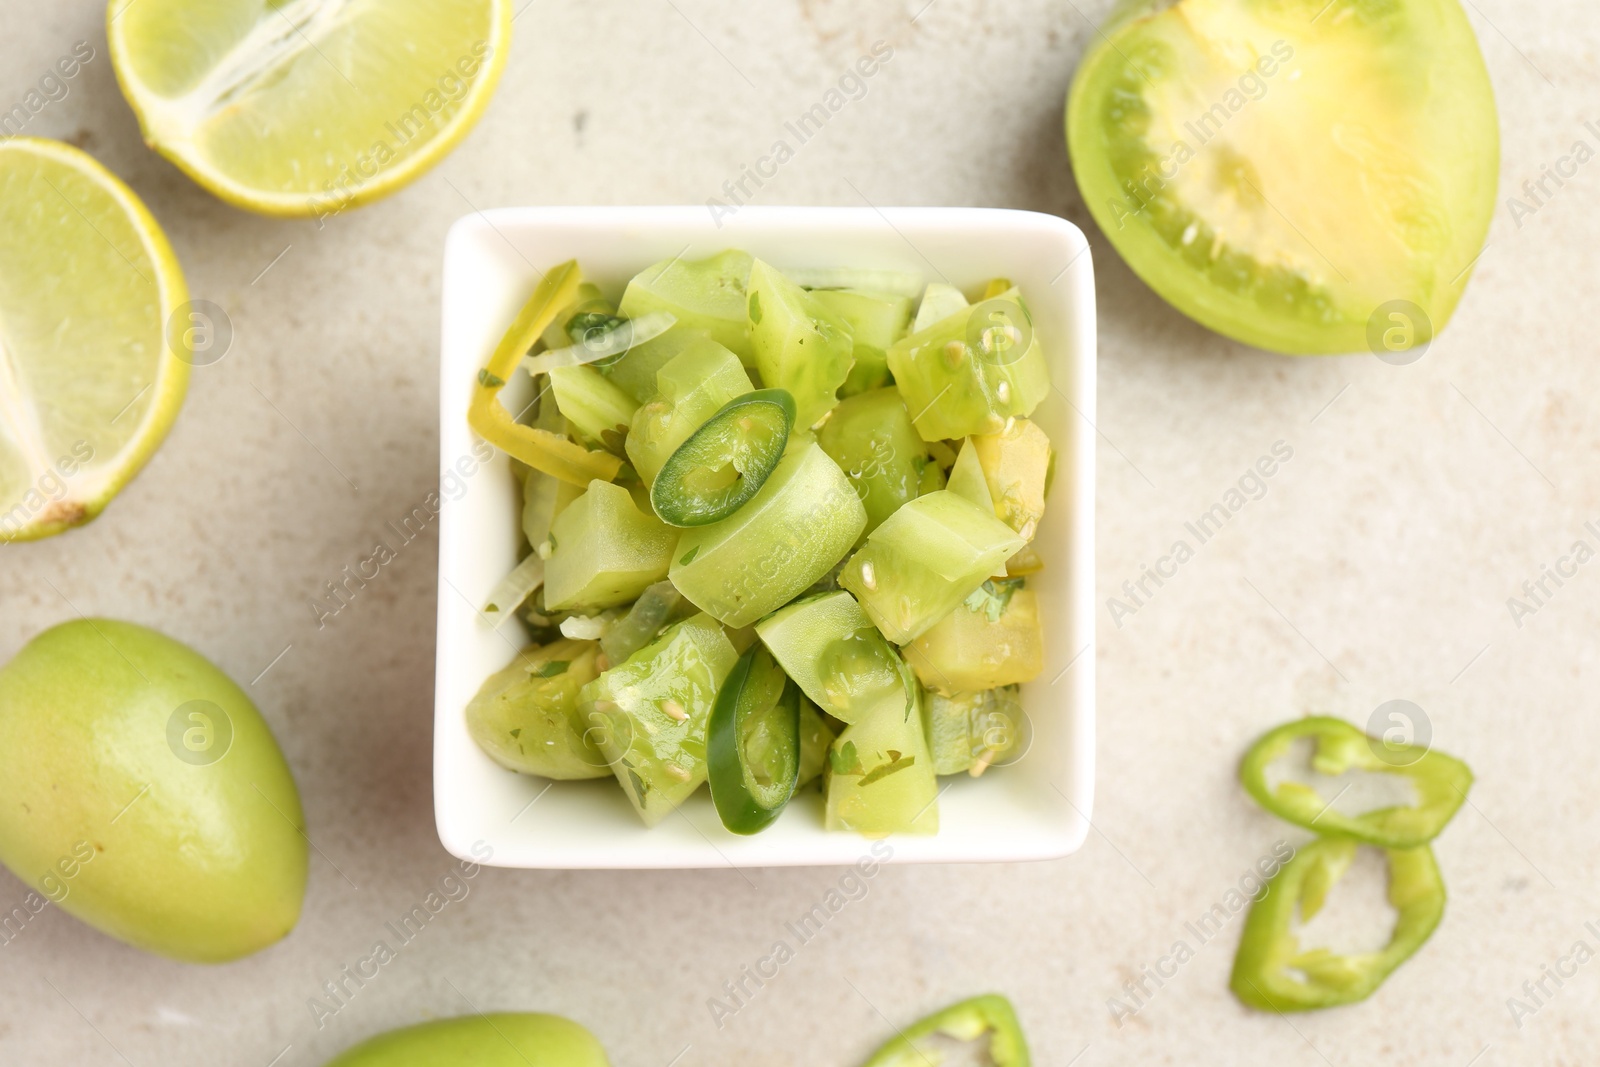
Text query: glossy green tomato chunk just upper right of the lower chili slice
755 590 901 723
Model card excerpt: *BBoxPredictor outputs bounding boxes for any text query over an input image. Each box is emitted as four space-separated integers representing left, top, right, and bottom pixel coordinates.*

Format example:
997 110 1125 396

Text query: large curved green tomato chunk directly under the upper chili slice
670 445 870 627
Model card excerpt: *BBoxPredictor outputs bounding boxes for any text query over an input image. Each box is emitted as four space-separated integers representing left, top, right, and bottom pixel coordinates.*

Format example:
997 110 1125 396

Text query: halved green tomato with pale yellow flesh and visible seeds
1066 0 1499 355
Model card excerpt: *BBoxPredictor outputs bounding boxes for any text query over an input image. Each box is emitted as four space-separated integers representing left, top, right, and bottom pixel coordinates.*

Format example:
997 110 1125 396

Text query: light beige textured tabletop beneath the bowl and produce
0 0 1600 1067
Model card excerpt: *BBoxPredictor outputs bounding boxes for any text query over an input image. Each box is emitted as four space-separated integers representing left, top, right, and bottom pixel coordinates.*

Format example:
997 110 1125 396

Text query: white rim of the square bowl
432 205 1096 869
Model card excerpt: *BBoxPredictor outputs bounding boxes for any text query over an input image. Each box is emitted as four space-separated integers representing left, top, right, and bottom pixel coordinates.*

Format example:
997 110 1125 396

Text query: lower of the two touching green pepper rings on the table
1229 837 1445 1013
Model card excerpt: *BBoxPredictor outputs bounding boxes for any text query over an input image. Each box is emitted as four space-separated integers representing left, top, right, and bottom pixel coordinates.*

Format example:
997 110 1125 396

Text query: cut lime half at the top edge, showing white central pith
107 0 510 219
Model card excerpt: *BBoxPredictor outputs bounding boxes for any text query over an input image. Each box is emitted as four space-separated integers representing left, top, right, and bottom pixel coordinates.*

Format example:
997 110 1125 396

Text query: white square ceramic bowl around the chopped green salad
434 206 1094 869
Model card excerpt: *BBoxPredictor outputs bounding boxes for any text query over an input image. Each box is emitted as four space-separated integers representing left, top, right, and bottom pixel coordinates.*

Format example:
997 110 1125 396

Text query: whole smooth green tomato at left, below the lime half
0 619 307 963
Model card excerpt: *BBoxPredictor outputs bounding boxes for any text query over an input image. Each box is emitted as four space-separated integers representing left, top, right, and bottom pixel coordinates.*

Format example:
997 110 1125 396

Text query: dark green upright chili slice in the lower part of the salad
706 643 800 833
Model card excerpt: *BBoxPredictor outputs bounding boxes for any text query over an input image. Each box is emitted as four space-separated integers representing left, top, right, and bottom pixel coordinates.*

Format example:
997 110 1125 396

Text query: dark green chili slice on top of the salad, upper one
650 389 795 526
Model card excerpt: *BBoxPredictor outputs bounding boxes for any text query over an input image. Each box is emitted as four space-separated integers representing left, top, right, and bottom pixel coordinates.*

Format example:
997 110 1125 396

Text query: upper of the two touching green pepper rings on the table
1238 717 1472 848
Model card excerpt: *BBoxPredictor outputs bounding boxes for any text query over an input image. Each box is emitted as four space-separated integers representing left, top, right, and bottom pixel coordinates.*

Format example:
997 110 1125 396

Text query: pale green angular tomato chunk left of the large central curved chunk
544 480 677 611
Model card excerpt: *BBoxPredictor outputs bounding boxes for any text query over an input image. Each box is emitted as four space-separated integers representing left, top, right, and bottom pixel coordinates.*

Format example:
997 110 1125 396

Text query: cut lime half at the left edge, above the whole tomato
0 138 189 541
